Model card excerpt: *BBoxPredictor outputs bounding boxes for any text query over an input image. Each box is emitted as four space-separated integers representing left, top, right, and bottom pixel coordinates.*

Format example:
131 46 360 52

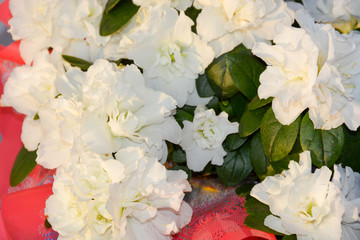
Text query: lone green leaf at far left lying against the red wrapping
10 146 37 187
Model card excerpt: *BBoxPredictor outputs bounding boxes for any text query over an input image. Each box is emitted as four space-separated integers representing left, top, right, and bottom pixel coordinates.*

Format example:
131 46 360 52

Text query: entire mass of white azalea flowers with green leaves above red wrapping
1 0 360 240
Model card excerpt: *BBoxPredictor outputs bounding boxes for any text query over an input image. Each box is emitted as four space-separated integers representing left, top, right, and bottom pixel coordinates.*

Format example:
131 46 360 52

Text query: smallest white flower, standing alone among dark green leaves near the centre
180 105 239 172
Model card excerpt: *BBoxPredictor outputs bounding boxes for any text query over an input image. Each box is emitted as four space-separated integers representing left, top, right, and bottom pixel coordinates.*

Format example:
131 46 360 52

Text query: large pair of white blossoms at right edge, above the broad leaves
253 9 360 130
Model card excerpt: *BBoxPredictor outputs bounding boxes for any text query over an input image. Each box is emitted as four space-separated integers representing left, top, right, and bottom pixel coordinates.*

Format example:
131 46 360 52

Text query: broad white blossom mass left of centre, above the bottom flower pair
33 60 181 168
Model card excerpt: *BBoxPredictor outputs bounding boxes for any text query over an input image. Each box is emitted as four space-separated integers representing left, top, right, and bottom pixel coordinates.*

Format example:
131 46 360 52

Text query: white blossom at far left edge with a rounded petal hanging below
1 48 68 151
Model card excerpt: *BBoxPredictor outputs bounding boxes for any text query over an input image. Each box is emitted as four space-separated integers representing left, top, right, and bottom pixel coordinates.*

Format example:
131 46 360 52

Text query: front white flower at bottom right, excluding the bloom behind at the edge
250 152 344 240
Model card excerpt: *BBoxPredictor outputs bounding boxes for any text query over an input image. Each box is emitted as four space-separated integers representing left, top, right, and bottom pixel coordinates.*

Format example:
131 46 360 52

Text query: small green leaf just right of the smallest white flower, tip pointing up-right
239 106 269 137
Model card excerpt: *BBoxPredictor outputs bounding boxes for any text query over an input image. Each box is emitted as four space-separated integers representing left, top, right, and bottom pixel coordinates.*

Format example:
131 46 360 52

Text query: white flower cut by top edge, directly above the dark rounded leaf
194 0 293 57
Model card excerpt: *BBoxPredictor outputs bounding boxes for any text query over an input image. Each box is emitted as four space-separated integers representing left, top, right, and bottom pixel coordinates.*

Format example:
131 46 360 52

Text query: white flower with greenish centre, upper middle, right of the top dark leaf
107 5 214 107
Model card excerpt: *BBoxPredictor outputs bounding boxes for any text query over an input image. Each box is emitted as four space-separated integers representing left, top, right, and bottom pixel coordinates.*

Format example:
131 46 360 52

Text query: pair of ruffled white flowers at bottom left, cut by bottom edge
45 147 192 240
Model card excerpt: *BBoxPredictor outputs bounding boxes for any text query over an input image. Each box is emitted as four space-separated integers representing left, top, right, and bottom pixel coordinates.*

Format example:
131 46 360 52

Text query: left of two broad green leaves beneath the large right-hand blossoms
260 108 301 161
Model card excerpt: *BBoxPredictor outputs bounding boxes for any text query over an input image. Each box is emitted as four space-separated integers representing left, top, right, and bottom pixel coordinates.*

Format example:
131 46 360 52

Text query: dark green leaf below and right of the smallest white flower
216 142 252 187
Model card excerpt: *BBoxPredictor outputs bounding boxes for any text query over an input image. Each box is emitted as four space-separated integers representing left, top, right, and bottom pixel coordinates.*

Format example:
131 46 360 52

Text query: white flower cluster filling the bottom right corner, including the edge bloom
251 152 360 240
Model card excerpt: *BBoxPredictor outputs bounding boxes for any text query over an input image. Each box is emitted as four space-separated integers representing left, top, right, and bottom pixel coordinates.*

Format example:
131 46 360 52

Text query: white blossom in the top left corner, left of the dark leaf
9 0 109 64
